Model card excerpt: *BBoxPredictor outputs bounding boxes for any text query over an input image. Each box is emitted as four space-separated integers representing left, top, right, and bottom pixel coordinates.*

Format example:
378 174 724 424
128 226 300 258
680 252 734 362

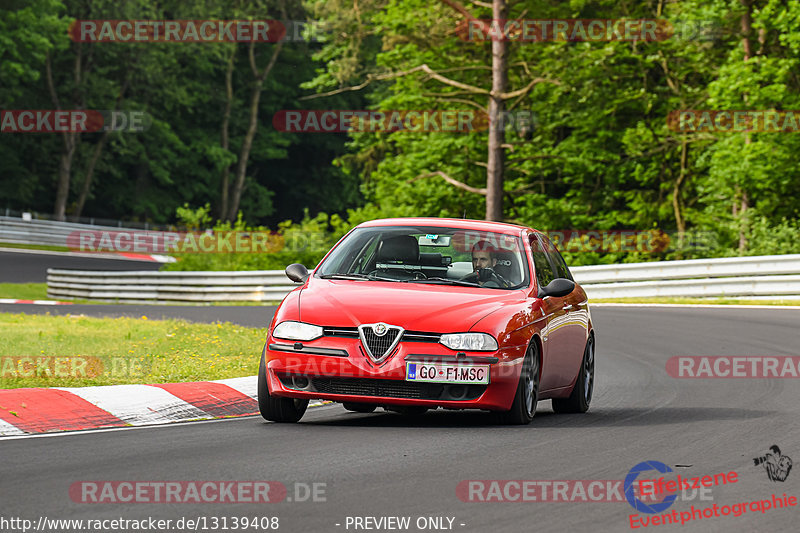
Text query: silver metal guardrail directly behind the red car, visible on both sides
47 254 800 303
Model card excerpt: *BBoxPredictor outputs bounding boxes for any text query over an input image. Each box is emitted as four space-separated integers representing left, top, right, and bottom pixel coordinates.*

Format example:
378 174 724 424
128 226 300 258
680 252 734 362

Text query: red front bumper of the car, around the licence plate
264 336 526 410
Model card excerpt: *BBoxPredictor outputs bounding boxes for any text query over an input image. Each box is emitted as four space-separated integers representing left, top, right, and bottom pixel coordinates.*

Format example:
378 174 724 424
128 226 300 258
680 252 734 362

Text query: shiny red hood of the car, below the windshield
300 278 522 333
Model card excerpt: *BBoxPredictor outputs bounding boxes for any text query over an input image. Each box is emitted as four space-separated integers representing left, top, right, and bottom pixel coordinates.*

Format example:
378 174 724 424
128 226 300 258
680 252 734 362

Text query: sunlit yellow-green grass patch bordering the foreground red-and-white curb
0 313 266 389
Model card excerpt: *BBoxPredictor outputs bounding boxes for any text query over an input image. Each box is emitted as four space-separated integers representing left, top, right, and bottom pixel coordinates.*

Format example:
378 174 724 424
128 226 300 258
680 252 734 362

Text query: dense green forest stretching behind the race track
0 0 800 269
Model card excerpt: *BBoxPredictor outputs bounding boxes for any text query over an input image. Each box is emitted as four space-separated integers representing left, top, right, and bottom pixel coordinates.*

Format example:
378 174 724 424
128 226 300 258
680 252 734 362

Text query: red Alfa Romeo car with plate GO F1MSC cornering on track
258 218 595 424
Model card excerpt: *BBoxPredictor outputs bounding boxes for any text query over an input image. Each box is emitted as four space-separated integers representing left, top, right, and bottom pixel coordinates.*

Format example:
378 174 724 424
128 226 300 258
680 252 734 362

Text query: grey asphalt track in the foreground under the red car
0 307 800 532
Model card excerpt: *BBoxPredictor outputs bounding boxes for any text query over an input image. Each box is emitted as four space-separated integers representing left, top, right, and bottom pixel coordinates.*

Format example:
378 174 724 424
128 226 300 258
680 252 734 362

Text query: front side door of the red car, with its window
530 234 574 391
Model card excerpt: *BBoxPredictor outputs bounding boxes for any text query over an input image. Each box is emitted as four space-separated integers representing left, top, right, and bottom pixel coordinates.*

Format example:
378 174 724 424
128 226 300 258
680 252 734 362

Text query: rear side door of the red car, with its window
541 235 589 382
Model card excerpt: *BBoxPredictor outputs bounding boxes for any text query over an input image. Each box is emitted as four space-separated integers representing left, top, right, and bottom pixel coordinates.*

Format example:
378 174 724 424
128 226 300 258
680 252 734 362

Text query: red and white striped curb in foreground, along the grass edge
0 376 322 437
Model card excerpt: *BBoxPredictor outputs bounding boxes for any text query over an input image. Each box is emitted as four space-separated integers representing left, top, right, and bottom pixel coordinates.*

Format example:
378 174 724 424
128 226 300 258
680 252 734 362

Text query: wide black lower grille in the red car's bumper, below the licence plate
278 374 486 401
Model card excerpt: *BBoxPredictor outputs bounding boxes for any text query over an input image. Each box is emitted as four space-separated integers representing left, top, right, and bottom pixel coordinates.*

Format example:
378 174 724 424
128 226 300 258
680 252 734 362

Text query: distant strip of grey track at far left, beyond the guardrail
0 249 161 283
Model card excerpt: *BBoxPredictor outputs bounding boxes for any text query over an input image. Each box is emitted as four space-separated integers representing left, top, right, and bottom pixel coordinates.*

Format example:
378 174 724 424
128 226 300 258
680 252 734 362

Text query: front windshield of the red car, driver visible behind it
314 226 529 289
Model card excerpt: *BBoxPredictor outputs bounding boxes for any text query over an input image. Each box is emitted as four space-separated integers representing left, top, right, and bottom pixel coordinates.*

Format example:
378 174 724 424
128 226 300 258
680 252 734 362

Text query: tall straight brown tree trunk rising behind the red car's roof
486 0 508 221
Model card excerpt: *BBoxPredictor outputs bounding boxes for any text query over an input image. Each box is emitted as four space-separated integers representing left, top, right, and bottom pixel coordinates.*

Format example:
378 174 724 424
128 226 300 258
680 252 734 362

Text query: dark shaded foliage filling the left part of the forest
0 0 361 225
